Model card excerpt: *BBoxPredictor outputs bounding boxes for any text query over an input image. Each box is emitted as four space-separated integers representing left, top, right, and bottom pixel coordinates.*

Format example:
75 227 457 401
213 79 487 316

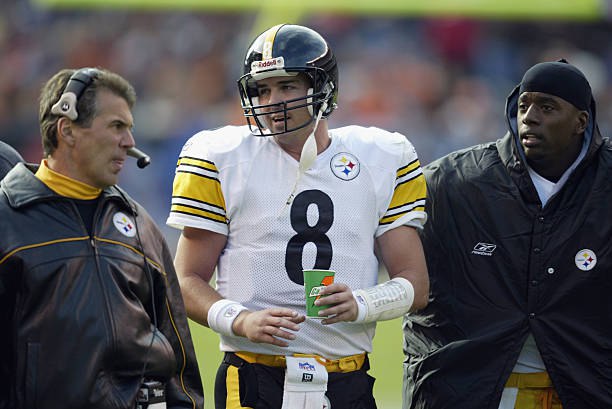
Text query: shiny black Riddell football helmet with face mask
238 24 338 136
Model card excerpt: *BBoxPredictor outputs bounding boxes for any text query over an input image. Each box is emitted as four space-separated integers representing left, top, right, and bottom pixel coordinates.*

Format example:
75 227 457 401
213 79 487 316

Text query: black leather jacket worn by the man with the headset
0 164 204 409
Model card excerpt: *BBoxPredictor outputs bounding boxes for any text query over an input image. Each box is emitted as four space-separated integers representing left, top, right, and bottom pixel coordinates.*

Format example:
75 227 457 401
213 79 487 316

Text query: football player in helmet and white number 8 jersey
167 25 429 409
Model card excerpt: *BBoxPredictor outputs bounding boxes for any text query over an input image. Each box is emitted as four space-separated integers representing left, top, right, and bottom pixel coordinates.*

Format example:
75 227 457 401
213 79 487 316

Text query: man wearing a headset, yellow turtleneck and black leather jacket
0 68 204 409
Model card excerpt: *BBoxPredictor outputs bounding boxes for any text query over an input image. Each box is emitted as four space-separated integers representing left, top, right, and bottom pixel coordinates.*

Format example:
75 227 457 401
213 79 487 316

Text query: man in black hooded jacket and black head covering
404 60 612 409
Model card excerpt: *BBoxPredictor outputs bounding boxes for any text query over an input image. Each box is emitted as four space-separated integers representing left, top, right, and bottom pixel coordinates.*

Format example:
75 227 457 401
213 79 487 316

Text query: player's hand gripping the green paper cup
315 283 358 325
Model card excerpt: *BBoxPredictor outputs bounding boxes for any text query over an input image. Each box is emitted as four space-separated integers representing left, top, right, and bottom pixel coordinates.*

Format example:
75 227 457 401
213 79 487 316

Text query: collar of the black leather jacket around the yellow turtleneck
1 163 136 211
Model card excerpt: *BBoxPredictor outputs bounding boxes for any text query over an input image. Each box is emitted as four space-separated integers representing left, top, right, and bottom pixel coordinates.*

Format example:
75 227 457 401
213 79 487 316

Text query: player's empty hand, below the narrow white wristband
232 308 306 347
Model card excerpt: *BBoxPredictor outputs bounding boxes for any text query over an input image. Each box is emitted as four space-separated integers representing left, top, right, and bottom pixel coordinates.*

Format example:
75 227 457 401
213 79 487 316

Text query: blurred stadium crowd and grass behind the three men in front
0 0 612 409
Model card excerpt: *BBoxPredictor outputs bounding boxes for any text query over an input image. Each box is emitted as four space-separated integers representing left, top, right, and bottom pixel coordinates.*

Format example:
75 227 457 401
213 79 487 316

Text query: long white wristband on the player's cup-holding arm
353 277 414 323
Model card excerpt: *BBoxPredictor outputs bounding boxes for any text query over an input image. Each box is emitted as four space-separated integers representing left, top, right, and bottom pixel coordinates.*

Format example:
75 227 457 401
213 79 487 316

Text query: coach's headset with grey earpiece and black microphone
51 67 151 169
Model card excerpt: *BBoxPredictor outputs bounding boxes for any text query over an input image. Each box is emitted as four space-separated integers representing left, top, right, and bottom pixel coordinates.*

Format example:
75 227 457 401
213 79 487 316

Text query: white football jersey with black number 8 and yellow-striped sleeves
167 126 426 359
